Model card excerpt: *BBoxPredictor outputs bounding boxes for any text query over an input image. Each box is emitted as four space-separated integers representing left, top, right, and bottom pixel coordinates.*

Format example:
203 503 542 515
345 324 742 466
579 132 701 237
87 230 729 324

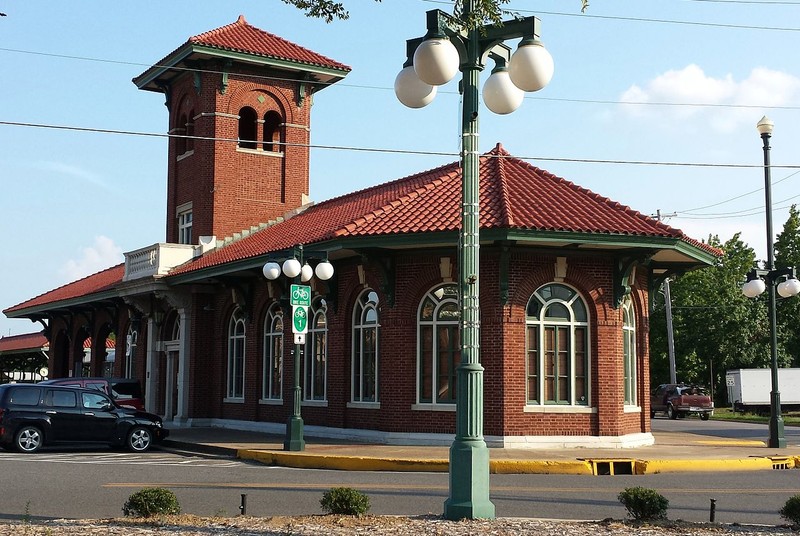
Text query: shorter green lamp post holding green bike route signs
262 245 333 451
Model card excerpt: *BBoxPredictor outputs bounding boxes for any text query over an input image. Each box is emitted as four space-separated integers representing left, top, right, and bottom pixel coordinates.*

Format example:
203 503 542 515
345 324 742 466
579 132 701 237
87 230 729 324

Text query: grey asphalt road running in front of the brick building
0 446 800 524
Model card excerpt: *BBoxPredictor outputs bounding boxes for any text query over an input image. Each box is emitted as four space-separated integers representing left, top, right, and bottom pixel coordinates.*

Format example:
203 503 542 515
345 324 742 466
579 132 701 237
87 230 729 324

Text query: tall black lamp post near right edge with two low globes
742 115 800 448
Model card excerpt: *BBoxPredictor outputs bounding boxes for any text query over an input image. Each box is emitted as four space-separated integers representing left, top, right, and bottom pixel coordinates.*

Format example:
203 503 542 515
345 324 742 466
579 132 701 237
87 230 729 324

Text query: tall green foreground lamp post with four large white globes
395 0 553 519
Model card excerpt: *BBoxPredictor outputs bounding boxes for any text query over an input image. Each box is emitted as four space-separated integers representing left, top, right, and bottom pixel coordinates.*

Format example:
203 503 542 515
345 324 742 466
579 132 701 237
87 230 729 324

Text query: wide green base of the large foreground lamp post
444 439 495 521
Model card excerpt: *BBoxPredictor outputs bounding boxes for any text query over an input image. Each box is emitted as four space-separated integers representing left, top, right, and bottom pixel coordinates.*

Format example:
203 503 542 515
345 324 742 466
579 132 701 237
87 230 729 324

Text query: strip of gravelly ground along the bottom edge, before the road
0 515 797 536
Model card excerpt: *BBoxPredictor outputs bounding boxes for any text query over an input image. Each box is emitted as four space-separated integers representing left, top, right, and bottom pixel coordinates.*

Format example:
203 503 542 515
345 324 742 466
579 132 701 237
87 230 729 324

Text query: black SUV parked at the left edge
0 382 169 453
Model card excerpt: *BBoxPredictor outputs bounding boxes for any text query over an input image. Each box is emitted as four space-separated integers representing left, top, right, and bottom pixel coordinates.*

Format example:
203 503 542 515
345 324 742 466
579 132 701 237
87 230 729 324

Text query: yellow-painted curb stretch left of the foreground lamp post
236 450 449 473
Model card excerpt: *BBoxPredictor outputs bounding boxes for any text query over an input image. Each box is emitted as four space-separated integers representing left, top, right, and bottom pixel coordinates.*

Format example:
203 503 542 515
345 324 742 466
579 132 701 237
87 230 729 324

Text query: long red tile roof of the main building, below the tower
0 144 721 312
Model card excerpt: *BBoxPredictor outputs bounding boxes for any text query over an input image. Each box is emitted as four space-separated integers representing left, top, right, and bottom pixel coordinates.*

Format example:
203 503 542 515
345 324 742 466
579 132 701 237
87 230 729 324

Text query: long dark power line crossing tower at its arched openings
6 121 800 170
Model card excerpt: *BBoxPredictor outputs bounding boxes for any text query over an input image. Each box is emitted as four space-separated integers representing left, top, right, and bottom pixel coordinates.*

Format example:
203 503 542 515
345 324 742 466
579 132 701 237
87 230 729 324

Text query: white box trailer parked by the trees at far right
725 368 800 413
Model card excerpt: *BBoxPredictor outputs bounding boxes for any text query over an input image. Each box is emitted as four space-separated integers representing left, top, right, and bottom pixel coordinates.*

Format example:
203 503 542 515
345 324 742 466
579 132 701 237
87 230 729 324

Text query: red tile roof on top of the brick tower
188 15 351 71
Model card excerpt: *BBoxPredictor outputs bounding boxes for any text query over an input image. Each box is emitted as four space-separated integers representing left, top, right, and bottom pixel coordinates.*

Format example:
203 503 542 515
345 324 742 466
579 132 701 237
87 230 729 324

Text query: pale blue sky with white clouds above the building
0 0 800 335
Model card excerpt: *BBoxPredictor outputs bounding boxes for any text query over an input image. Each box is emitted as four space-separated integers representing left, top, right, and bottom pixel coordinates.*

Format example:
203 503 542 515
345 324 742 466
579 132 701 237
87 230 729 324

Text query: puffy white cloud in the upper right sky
620 64 800 132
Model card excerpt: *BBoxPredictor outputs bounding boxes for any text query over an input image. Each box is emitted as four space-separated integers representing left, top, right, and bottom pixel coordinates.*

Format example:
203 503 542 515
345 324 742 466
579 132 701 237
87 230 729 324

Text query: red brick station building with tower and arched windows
4 17 719 447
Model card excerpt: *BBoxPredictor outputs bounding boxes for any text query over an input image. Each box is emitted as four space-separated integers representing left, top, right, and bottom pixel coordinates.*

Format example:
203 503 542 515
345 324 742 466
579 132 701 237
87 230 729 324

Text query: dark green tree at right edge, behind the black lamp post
775 205 800 367
